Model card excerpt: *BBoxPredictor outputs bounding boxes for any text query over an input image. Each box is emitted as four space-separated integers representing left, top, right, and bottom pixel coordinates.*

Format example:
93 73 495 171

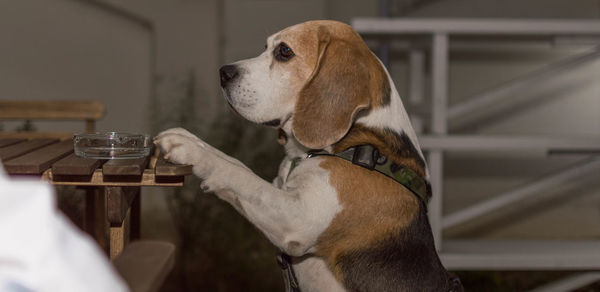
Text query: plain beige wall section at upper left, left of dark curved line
0 0 153 131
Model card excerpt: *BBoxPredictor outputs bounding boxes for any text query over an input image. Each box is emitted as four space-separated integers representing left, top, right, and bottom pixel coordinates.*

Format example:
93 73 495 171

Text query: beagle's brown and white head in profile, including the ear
220 21 390 149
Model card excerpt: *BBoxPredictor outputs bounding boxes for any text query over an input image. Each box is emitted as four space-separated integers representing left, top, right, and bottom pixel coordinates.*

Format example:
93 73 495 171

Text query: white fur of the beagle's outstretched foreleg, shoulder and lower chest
155 126 344 292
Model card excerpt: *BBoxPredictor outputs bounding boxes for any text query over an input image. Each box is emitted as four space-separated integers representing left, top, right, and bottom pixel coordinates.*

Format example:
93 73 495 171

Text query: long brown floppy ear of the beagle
292 27 389 149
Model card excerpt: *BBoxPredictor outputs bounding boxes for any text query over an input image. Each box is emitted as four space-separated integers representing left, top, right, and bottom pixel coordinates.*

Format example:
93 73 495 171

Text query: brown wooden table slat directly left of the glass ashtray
4 140 73 175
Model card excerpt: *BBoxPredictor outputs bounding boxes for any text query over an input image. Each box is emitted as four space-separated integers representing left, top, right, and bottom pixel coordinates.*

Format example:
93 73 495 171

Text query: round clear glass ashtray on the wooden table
73 132 152 159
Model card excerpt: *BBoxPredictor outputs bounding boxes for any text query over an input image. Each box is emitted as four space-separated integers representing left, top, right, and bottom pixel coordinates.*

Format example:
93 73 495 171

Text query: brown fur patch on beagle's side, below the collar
317 157 419 281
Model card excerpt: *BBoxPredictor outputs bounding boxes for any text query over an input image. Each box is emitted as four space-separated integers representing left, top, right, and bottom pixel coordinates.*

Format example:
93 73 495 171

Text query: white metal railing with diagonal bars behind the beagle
352 18 600 291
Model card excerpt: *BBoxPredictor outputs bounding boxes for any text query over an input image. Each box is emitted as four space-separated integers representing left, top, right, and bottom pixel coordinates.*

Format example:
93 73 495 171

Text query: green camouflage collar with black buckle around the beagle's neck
288 144 430 211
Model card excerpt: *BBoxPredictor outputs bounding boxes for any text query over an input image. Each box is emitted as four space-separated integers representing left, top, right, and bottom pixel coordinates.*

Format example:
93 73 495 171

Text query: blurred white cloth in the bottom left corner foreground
0 164 128 292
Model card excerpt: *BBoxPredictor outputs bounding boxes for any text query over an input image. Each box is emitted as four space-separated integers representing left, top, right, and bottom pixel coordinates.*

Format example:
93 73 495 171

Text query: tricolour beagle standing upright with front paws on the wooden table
155 21 463 292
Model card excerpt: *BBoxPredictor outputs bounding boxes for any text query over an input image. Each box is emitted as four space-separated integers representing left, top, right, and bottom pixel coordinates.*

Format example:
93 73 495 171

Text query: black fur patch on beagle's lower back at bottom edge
337 209 453 292
